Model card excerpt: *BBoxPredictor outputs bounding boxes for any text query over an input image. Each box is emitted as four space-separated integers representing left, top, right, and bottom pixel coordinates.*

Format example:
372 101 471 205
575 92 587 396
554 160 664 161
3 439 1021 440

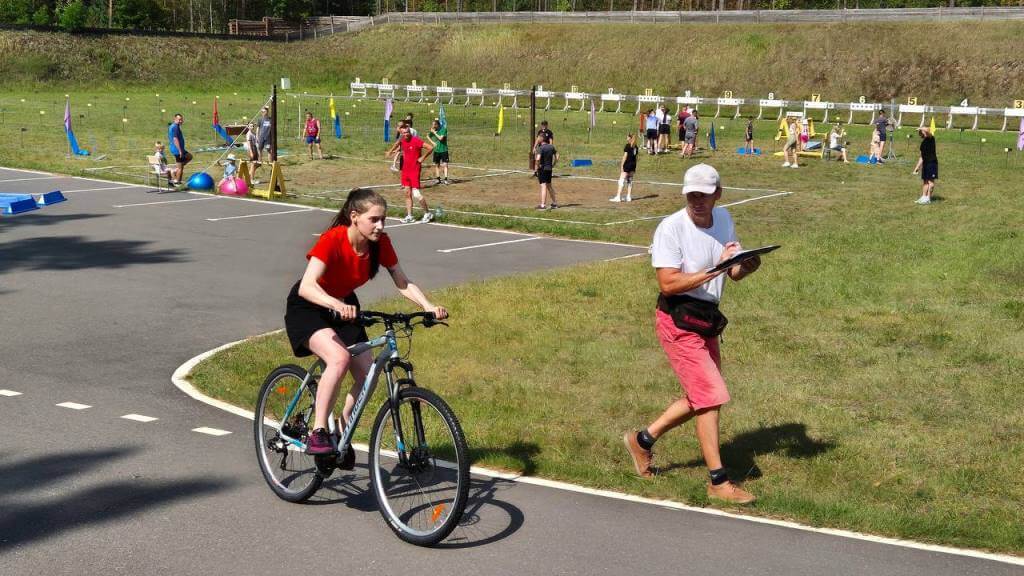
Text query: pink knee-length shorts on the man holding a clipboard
654 311 729 410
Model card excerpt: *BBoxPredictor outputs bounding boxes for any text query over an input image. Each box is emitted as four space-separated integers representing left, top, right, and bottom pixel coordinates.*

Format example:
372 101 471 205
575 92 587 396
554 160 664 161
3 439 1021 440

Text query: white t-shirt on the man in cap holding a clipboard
650 208 739 302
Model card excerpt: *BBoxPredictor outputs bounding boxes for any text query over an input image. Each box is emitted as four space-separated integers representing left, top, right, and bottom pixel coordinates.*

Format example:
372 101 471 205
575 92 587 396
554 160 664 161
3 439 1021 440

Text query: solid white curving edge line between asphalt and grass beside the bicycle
171 330 1024 566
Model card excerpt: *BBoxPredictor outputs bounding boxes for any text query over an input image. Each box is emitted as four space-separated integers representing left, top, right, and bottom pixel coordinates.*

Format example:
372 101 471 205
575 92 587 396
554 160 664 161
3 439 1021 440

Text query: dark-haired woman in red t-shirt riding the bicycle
285 189 447 454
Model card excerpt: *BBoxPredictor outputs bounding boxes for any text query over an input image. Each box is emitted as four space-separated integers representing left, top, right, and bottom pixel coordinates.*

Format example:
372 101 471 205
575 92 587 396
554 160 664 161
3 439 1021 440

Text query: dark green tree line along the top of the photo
0 0 1024 34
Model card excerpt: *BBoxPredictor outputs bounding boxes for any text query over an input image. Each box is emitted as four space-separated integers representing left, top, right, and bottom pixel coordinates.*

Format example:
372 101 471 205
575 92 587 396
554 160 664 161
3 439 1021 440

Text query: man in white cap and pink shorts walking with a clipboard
624 164 761 504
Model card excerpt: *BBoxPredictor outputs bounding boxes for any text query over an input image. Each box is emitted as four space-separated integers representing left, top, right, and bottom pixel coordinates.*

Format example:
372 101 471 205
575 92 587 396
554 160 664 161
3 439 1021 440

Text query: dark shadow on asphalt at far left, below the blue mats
0 236 185 274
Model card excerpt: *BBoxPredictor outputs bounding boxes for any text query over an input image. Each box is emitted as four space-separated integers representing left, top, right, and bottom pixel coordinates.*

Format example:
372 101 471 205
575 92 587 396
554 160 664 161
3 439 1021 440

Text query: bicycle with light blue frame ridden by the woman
254 311 469 546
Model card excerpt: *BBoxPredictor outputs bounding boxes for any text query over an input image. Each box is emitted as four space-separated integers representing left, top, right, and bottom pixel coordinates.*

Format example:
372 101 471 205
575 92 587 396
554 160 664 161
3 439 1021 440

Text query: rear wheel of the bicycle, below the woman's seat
253 364 324 502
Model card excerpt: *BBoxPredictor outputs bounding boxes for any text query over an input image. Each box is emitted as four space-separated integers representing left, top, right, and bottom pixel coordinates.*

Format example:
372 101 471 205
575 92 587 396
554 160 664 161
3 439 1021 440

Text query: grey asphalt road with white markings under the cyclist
0 163 1024 576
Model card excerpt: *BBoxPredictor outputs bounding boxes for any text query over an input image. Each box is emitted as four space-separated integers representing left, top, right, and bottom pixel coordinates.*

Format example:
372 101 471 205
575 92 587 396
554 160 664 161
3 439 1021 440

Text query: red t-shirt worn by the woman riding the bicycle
306 225 398 299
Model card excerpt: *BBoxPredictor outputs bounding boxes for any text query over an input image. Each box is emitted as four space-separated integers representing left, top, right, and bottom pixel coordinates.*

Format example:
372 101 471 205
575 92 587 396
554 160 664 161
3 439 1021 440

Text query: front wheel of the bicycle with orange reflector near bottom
370 387 469 546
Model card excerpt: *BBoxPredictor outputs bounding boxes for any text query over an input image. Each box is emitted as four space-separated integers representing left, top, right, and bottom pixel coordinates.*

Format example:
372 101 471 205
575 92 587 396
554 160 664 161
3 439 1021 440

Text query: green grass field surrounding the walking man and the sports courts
0 24 1024 553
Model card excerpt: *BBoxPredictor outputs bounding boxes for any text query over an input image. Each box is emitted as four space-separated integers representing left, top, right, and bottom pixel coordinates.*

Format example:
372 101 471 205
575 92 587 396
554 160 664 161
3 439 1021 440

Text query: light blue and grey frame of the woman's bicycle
275 327 424 463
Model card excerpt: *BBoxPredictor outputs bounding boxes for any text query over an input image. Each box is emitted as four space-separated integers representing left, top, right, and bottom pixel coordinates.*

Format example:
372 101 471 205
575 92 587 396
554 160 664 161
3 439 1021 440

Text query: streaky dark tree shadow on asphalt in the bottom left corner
0 448 232 553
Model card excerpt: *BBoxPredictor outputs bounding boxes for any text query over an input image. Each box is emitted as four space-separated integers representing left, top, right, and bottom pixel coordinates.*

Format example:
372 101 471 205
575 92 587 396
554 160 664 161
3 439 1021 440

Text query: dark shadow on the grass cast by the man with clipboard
659 422 836 482
